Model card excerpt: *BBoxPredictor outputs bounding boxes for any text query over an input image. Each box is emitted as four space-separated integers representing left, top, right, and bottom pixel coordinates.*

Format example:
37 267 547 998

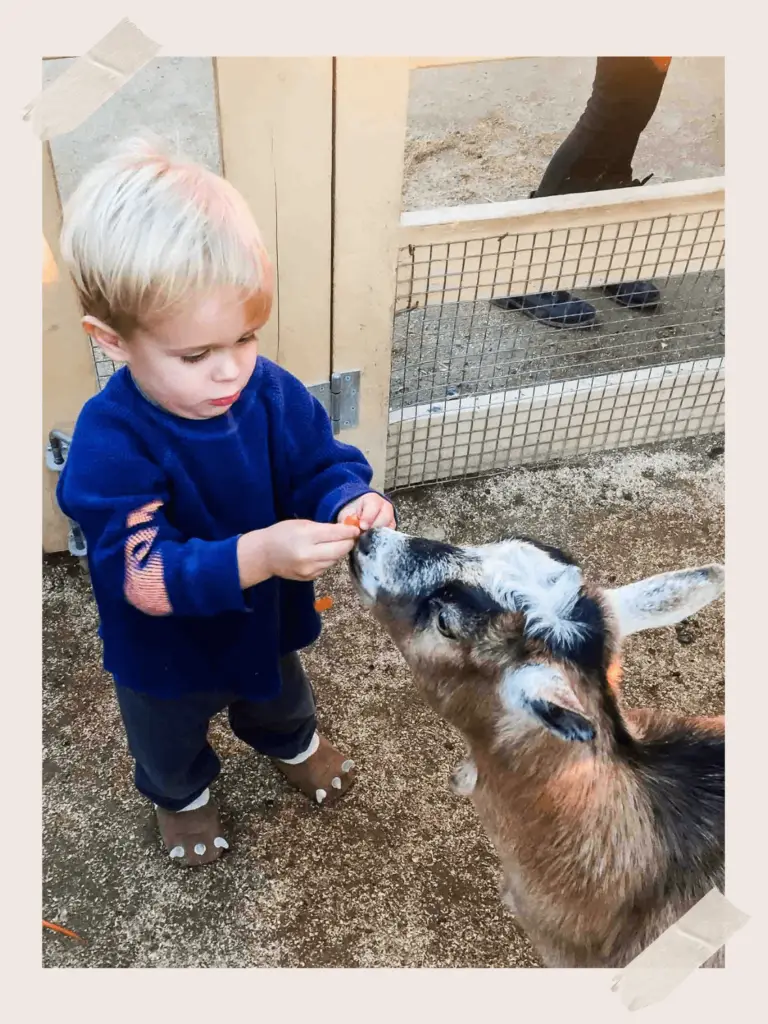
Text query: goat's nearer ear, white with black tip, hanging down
501 665 595 742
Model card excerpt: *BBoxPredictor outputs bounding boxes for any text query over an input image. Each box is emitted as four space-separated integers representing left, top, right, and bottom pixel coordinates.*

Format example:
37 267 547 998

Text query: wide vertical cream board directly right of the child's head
214 57 333 384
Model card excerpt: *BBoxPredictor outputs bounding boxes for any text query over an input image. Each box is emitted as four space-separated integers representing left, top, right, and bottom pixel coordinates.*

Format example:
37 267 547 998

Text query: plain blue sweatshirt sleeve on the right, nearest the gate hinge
281 372 385 522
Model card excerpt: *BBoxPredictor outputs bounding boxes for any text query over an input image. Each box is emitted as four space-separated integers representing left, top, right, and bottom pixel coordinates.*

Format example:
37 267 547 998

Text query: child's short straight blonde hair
60 137 271 338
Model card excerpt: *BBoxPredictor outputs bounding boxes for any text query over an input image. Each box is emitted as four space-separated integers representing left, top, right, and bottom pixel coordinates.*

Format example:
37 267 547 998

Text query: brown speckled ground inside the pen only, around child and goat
43 437 724 968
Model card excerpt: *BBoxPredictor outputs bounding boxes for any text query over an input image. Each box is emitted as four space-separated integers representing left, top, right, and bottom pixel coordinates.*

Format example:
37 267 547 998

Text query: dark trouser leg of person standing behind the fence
535 57 667 197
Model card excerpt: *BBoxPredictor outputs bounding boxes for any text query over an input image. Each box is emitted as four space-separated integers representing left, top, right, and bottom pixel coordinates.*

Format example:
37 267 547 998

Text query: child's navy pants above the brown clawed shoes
115 654 316 811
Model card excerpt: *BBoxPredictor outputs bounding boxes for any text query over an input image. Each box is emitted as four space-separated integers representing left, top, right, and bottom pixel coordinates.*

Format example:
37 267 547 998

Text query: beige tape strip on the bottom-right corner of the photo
611 889 750 1010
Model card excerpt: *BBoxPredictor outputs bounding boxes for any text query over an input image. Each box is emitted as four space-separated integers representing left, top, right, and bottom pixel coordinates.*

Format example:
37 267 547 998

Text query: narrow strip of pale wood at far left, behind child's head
41 142 98 552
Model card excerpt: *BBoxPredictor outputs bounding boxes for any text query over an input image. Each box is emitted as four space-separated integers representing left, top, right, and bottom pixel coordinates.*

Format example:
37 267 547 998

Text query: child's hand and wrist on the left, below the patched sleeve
238 519 360 588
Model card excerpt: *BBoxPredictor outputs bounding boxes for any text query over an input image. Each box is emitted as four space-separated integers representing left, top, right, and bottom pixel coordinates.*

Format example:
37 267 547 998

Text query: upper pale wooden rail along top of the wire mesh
396 178 725 310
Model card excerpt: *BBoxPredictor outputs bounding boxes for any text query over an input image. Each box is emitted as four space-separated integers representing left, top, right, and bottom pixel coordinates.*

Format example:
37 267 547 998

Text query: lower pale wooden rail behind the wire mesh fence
386 356 725 487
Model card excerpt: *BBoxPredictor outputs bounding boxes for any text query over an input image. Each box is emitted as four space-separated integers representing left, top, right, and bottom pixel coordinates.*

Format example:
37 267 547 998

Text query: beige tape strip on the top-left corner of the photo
24 17 160 140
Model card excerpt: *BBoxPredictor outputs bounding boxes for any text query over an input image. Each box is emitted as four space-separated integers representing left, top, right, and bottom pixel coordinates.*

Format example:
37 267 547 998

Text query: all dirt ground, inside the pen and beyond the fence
43 58 724 968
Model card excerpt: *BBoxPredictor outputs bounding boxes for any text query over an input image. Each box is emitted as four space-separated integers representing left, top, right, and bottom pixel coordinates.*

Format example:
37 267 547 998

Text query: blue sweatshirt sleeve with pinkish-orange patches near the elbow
56 410 247 615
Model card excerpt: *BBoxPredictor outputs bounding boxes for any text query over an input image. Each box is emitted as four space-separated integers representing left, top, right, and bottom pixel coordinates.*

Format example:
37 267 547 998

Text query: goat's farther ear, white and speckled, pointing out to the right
603 565 725 636
